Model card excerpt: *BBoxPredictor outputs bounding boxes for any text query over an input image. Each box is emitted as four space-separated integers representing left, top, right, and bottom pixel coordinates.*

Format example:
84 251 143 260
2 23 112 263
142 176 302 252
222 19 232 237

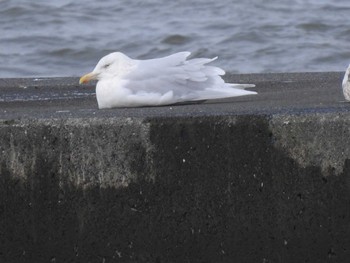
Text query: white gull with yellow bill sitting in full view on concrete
79 52 257 109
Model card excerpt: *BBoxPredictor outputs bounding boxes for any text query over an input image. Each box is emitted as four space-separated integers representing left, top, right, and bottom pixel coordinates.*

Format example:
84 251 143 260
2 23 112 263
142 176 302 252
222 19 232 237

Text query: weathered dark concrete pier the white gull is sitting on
0 72 350 263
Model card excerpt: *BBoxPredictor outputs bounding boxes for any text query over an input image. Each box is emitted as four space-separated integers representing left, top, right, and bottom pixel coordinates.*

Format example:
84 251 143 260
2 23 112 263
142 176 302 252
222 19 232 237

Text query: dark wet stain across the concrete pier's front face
0 115 350 263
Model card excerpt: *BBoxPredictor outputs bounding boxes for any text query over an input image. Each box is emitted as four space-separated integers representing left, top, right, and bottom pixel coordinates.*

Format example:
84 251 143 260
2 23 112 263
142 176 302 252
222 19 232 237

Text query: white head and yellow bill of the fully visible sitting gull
79 52 133 84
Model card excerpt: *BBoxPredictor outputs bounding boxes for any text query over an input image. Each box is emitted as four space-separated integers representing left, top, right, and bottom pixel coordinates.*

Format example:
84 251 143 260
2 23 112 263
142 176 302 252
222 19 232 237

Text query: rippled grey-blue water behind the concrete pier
0 0 350 77
